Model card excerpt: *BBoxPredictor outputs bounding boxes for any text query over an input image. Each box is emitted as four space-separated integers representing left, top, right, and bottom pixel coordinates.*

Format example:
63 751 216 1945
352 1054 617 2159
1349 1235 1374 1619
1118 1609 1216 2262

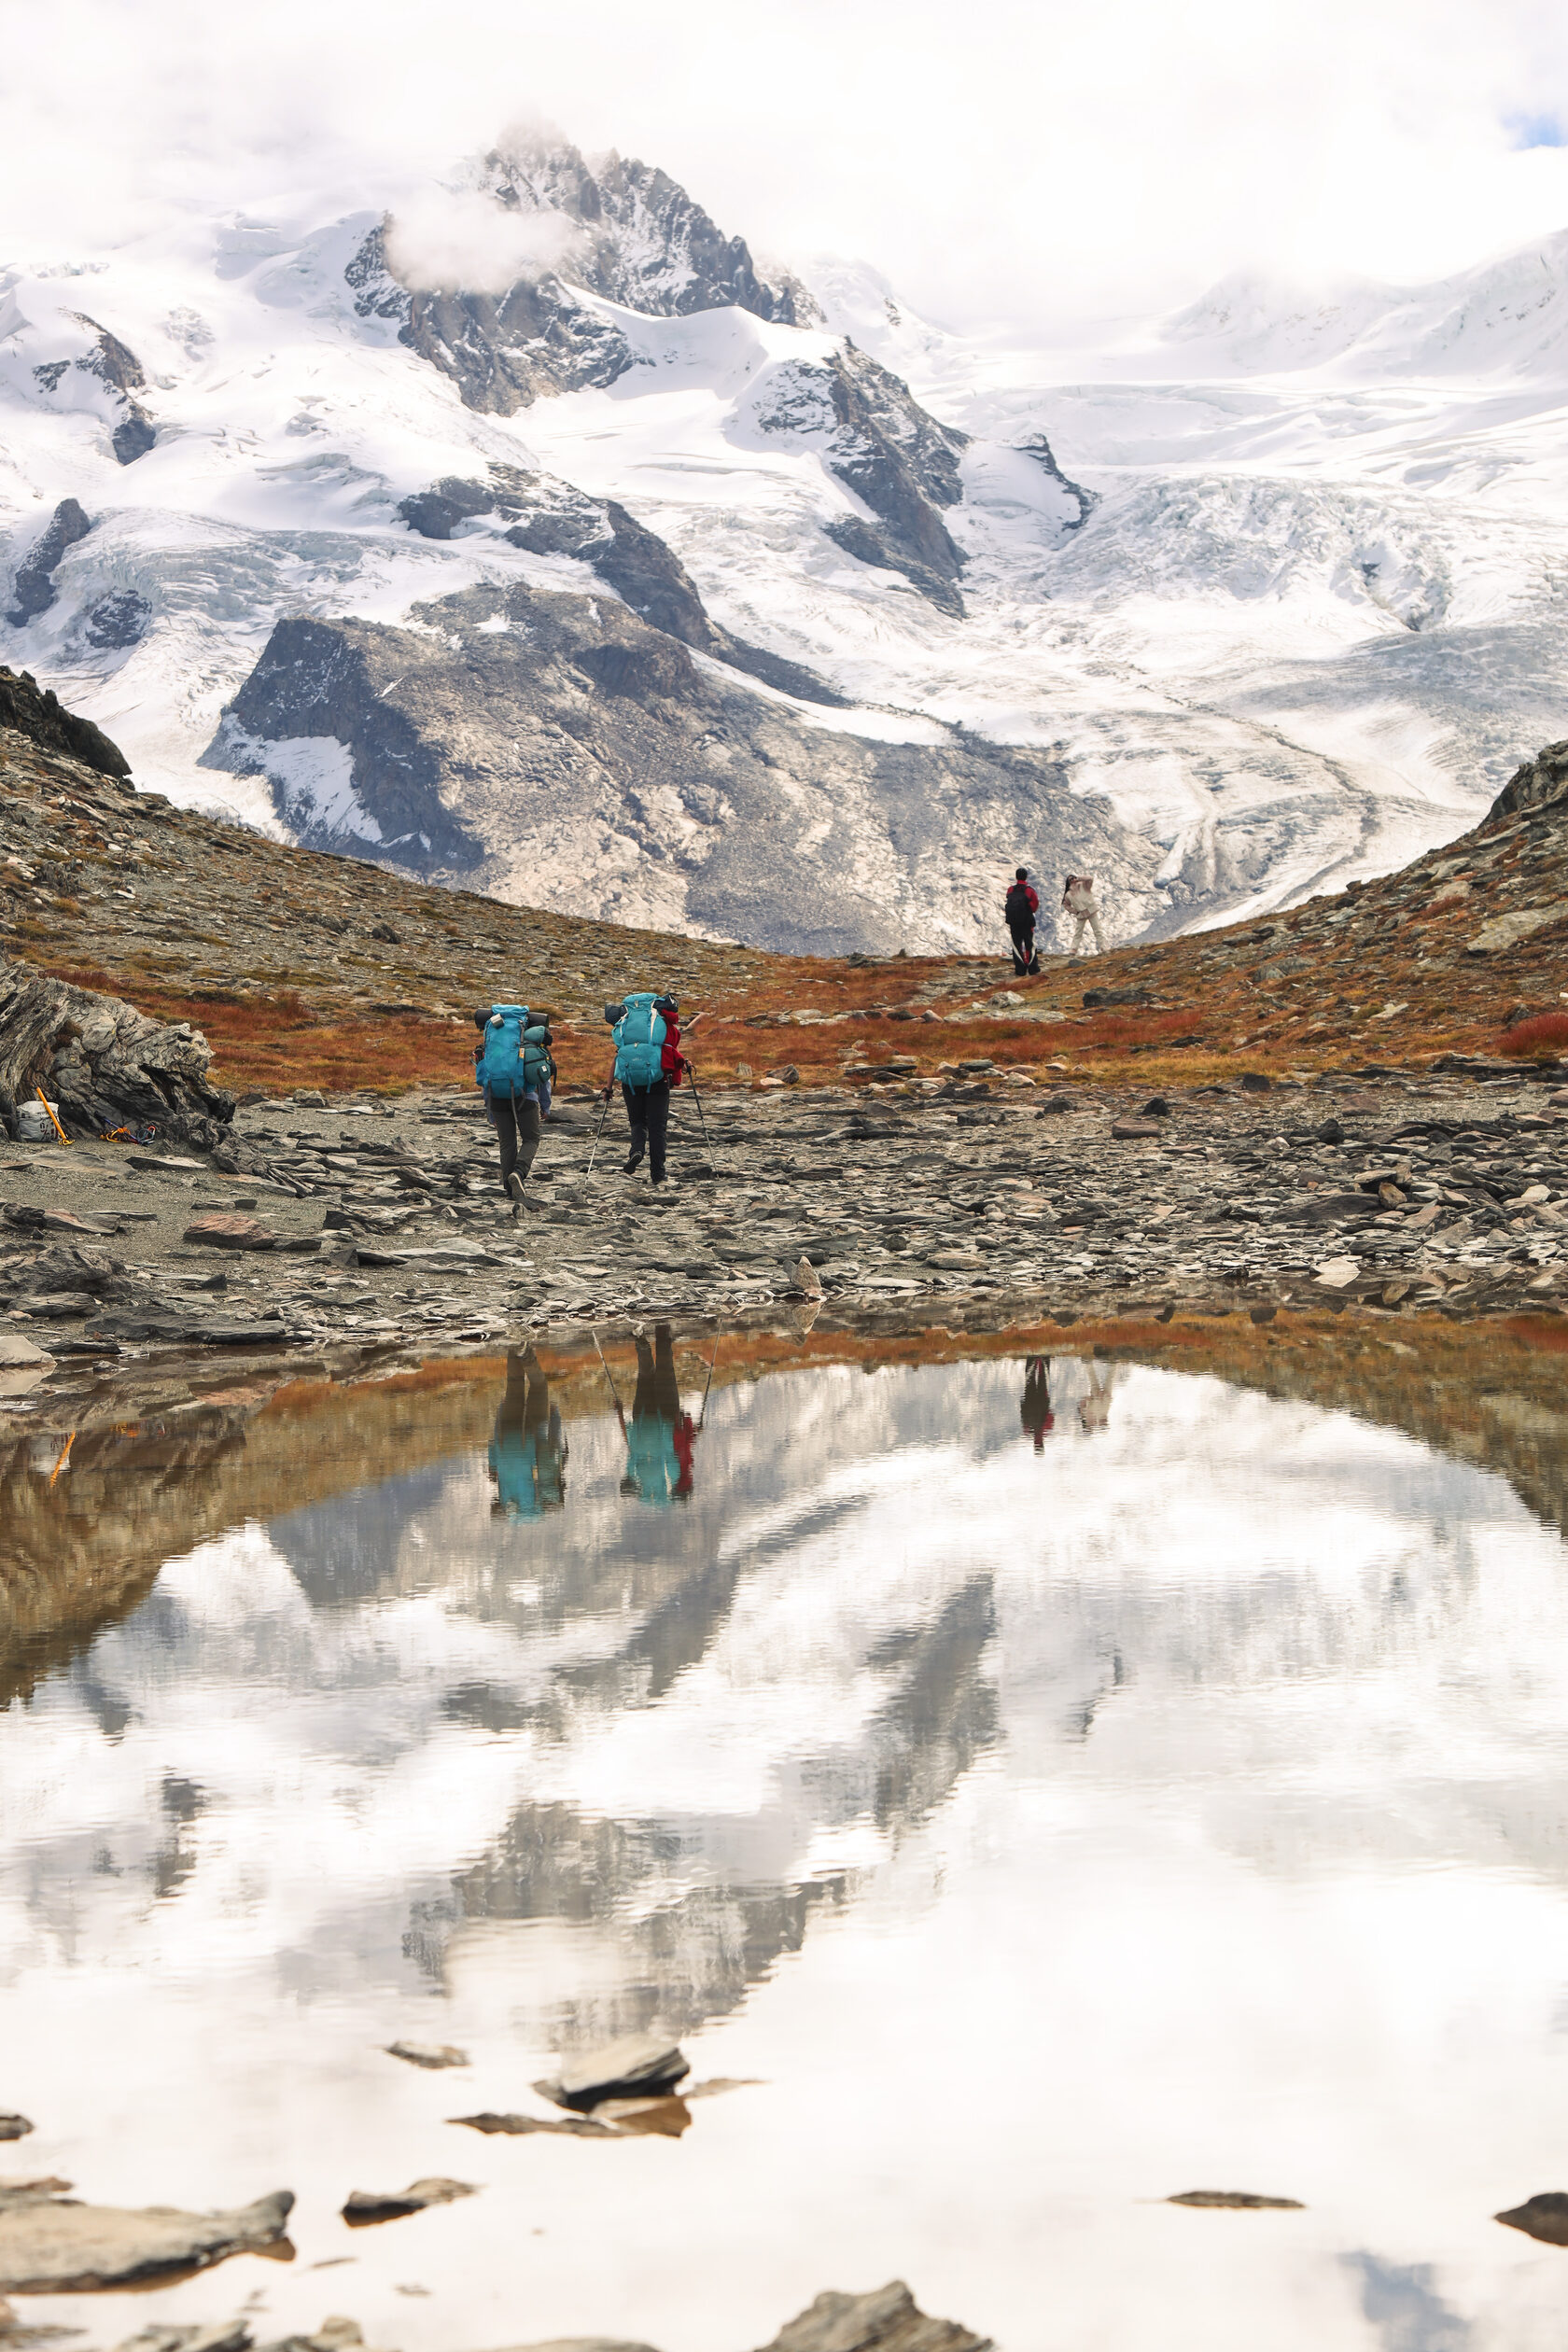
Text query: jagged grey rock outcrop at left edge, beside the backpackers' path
0 962 235 1150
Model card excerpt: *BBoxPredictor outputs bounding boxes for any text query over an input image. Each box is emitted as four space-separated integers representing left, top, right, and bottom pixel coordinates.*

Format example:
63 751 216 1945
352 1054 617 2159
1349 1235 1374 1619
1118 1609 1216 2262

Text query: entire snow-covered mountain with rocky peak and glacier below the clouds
0 141 1568 948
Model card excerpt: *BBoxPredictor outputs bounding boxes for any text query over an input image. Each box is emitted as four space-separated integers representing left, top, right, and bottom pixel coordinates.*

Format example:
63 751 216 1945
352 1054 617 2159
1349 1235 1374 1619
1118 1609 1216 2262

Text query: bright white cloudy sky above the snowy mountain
0 0 1568 339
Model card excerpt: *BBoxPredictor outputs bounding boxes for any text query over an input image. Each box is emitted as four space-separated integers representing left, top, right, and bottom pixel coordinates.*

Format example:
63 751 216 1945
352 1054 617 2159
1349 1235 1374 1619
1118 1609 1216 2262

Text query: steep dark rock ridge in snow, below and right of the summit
749 343 969 614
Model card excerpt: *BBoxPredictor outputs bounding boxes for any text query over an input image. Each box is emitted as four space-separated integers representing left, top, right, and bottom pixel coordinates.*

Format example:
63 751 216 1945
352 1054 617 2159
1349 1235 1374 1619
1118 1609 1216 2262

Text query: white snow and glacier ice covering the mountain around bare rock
0 149 1568 945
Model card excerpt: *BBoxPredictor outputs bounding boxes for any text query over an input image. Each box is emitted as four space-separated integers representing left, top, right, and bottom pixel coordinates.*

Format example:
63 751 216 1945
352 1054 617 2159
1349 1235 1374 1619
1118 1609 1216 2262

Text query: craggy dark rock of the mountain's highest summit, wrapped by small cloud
343 141 811 416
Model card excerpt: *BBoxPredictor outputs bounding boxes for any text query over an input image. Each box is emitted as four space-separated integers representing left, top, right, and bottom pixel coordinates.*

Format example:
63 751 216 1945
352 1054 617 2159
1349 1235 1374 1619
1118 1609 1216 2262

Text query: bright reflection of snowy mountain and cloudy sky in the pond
0 1362 1568 2352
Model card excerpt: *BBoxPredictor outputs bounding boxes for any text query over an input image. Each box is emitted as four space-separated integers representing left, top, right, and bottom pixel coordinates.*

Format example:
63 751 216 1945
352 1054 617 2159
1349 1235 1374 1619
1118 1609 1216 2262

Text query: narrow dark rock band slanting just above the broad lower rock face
398 466 844 708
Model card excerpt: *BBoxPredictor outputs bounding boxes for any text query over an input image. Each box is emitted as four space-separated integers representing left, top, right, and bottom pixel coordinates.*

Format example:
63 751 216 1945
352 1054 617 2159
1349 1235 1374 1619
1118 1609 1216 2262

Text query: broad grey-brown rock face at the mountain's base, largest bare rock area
204 583 1159 953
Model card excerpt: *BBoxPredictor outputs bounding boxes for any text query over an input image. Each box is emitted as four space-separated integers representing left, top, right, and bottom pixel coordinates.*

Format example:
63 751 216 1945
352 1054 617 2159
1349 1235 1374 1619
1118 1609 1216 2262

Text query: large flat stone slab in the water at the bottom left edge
0 2190 294 2296
